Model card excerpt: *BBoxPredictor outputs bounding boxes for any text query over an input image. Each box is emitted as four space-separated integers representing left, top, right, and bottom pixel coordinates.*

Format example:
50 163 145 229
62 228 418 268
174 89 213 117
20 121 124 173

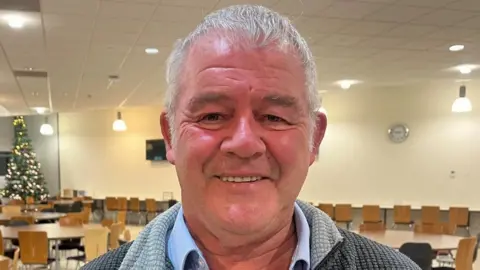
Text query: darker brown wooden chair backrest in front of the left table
18 231 48 264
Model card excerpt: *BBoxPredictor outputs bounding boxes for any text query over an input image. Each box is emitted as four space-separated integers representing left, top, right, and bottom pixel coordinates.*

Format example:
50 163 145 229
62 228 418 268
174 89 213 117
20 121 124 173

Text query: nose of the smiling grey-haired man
221 117 266 159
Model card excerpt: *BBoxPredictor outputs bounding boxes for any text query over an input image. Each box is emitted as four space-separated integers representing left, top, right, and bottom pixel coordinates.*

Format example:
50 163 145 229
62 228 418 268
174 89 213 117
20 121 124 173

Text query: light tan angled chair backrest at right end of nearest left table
83 228 108 262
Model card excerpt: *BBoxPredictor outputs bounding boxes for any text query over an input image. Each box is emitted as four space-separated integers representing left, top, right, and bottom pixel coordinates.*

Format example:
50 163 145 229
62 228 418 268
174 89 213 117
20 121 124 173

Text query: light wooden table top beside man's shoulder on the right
355 230 463 250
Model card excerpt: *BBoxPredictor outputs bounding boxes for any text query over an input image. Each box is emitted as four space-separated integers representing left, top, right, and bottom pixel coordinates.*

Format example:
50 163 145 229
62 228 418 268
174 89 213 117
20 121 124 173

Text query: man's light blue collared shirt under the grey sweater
168 203 310 270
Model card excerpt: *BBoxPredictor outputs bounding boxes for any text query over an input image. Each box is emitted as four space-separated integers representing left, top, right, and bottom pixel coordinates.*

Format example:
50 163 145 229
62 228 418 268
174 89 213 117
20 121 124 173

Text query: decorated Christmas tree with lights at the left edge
2 116 48 201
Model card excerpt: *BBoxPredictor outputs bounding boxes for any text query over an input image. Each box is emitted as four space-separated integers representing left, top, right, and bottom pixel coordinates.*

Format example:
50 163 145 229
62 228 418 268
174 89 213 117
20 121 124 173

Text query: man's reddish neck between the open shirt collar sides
187 209 297 270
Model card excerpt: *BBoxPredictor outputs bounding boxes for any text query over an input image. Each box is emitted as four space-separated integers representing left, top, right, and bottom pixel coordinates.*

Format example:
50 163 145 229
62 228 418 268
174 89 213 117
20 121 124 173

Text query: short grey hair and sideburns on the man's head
165 5 321 149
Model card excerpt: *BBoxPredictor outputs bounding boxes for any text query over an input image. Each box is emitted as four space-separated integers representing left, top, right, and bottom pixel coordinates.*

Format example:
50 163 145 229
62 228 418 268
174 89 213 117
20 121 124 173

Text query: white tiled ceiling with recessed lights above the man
0 0 480 114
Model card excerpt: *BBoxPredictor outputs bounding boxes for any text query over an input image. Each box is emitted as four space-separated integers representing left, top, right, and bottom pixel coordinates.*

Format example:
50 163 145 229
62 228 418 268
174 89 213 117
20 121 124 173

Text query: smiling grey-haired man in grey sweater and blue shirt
84 5 419 270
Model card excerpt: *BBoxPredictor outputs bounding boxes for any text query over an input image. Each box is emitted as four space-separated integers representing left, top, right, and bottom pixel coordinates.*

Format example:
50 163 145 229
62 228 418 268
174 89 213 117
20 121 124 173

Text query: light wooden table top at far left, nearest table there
0 223 106 240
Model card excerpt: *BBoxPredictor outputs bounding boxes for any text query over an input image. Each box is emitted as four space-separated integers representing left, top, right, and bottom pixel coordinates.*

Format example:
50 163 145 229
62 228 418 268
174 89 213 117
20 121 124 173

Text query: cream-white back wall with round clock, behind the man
60 82 480 209
